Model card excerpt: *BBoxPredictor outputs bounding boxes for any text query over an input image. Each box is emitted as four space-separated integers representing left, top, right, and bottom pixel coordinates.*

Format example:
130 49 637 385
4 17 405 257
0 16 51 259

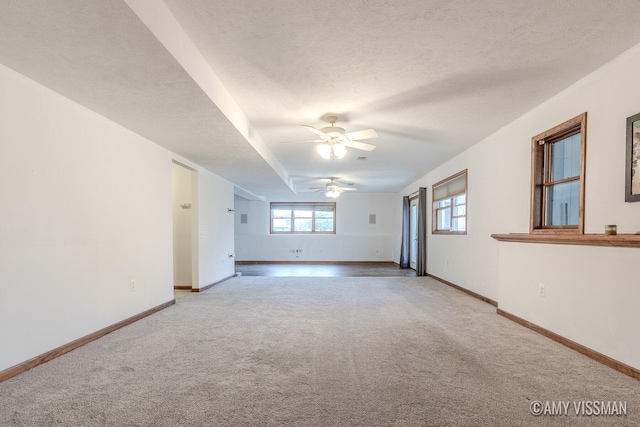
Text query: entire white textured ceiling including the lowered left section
0 0 640 198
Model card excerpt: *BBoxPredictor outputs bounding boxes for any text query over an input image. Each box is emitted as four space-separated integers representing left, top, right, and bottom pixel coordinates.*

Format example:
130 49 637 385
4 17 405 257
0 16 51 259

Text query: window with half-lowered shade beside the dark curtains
431 169 467 234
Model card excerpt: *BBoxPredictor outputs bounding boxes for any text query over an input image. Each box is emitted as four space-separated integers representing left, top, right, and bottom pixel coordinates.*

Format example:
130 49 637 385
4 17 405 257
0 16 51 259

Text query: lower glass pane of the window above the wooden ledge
545 180 580 226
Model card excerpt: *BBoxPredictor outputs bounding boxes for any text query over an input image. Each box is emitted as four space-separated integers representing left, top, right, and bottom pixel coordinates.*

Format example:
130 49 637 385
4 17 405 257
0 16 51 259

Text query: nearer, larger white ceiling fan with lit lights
283 116 378 159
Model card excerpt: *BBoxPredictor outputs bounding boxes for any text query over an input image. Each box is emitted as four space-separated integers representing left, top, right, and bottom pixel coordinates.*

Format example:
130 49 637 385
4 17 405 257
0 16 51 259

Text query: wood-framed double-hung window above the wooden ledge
529 113 587 234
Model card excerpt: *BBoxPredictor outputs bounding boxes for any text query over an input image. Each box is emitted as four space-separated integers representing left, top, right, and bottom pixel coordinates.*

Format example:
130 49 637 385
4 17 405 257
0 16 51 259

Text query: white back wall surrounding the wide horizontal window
235 192 399 262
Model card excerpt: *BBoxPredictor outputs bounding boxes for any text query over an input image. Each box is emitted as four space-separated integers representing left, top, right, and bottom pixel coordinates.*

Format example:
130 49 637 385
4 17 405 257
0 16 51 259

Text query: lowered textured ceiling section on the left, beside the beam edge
0 0 290 195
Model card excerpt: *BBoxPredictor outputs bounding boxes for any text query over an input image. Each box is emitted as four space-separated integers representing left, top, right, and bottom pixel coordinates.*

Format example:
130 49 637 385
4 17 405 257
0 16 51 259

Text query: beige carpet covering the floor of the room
0 277 640 426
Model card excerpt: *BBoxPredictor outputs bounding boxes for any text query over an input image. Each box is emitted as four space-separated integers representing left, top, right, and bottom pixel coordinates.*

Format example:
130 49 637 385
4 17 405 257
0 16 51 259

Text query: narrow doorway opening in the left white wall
171 161 198 290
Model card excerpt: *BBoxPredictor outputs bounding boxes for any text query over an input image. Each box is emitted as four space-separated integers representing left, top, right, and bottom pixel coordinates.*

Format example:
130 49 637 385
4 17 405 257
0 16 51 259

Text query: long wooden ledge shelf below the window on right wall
491 233 640 248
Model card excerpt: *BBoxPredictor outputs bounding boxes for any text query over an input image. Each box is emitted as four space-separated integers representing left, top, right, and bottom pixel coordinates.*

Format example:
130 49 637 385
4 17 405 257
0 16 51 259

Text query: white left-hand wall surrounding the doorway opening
0 66 233 371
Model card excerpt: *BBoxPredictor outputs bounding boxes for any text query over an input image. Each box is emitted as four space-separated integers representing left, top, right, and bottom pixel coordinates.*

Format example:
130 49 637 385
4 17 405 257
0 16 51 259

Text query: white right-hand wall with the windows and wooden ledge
396 41 640 368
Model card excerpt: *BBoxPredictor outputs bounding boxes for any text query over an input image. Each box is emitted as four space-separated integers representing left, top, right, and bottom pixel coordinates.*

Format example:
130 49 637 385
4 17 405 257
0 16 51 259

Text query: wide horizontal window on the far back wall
271 202 336 234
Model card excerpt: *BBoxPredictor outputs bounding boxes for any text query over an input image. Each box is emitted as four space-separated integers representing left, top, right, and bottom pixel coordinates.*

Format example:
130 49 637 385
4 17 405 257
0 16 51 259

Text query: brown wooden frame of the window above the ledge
529 112 587 234
